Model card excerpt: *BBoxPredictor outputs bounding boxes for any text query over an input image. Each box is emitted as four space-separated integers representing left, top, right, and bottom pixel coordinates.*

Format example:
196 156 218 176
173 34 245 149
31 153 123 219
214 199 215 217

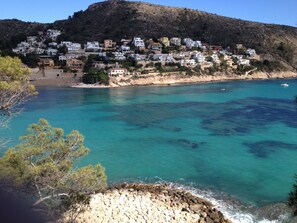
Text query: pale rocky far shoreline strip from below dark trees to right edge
70 71 297 88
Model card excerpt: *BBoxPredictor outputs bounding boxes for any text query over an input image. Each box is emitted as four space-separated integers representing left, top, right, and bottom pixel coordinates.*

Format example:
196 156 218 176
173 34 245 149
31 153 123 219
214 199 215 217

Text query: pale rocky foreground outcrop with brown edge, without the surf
61 184 231 223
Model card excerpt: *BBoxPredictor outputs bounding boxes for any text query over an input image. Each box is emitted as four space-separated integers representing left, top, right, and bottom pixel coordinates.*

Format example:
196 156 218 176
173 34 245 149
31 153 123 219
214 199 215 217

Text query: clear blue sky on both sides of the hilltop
0 0 297 27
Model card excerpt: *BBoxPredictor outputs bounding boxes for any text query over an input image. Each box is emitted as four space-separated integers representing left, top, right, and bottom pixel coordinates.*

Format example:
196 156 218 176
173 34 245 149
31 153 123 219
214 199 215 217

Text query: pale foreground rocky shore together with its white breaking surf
61 183 297 223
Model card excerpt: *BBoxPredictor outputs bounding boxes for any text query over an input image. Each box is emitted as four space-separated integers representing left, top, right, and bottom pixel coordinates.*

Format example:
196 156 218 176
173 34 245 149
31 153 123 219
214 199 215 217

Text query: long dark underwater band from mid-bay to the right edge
102 97 297 136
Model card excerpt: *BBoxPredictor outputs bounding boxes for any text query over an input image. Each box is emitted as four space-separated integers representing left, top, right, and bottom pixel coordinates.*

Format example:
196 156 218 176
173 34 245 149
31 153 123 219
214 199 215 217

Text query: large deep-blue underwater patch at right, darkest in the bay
201 98 297 136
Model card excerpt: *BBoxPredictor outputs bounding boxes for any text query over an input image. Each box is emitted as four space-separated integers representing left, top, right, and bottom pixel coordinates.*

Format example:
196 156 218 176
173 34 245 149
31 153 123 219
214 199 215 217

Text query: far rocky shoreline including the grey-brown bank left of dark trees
31 71 297 88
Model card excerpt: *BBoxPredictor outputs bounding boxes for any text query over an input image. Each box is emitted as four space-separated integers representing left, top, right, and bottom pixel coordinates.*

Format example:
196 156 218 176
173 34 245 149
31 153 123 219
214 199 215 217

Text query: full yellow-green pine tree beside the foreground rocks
0 119 107 219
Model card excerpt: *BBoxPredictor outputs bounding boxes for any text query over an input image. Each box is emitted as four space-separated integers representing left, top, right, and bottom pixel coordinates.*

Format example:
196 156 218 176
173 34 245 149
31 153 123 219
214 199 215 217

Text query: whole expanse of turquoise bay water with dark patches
1 80 297 209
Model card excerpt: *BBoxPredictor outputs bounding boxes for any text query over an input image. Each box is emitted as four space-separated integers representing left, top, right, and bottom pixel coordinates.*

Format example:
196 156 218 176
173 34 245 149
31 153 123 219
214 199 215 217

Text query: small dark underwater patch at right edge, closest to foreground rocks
243 140 297 158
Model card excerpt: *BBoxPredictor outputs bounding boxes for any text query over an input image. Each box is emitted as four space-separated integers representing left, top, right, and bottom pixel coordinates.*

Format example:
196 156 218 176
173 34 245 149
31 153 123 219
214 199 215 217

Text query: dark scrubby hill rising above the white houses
0 0 297 69
